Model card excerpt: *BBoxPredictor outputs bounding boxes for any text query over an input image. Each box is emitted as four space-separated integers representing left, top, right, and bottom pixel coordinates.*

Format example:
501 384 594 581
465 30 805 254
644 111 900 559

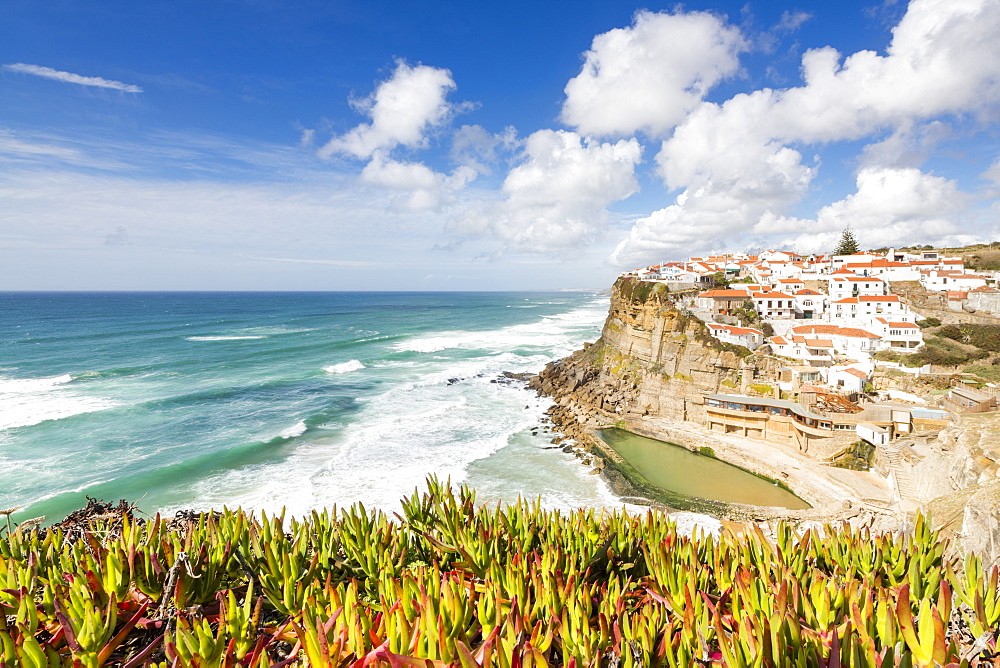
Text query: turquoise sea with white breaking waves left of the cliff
0 293 618 520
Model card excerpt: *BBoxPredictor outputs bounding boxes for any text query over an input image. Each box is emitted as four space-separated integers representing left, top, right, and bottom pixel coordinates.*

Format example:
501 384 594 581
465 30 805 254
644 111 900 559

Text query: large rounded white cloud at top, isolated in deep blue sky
561 11 745 137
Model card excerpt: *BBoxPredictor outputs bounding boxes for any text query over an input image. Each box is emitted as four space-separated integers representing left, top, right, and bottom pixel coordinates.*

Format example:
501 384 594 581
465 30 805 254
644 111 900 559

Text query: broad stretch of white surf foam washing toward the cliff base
159 294 622 516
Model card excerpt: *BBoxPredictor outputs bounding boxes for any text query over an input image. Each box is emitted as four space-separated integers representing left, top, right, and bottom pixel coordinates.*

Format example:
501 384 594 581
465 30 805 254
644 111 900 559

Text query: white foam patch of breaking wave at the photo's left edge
0 374 118 430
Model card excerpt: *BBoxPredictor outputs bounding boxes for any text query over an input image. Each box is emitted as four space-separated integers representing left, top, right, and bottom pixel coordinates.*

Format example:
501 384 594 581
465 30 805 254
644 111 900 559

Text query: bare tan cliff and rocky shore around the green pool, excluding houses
527 281 1000 560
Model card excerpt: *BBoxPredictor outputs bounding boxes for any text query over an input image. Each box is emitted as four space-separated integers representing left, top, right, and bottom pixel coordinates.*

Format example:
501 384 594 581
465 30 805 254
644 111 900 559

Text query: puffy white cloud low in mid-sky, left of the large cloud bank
452 130 642 254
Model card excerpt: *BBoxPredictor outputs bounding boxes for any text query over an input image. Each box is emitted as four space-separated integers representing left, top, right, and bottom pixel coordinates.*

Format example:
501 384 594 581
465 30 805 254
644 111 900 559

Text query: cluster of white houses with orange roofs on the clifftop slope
626 248 1000 462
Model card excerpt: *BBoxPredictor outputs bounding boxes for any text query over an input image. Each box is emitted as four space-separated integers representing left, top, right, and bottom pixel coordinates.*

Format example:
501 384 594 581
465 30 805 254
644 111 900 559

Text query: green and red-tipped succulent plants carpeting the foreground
0 478 1000 668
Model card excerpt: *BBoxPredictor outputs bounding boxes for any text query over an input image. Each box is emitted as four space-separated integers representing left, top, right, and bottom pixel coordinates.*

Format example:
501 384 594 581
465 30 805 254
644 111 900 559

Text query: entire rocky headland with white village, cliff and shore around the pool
531 240 1000 560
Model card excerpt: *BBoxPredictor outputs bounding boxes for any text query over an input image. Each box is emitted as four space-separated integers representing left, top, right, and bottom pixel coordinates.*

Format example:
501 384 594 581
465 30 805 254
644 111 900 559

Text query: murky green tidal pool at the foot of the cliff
598 428 811 510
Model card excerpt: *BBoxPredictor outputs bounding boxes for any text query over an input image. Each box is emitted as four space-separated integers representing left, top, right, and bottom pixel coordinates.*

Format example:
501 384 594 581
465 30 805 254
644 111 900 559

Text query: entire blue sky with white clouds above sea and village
0 0 1000 290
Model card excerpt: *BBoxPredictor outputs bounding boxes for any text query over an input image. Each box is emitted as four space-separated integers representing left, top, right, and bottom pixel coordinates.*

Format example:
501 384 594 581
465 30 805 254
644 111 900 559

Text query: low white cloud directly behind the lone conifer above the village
753 167 978 253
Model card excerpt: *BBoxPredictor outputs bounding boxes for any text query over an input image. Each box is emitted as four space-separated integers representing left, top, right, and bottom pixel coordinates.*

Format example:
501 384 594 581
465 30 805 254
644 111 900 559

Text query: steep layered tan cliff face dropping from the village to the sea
532 278 780 434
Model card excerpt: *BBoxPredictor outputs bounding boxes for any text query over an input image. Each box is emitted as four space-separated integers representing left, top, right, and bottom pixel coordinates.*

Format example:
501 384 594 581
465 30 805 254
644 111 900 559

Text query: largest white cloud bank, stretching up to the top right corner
611 0 1000 265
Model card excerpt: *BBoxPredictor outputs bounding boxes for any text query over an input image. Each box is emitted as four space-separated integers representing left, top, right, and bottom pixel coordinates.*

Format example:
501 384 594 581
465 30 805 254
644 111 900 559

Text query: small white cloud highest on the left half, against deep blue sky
319 61 455 158
